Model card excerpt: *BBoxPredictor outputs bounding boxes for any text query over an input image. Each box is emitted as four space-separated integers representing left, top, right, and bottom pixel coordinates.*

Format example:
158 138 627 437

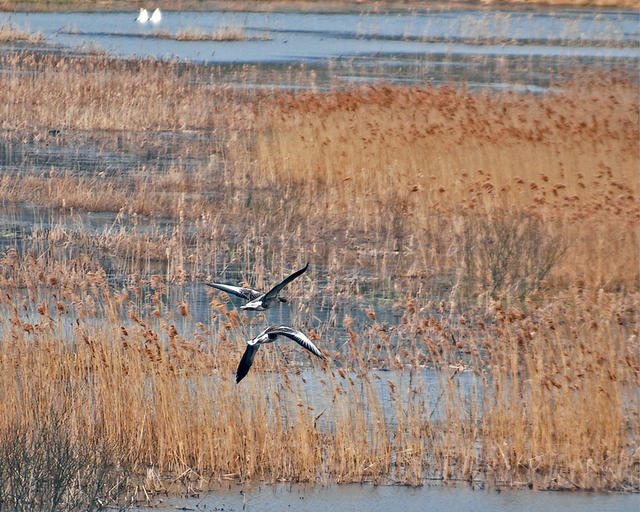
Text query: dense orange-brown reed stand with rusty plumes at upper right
254 75 640 294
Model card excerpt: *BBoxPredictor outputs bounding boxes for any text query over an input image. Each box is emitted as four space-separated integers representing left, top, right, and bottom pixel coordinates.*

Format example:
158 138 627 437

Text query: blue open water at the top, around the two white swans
0 9 640 91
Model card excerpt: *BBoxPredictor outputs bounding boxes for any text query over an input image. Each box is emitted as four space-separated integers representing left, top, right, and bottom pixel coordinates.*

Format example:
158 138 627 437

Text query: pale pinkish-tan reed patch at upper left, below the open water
1 52 255 133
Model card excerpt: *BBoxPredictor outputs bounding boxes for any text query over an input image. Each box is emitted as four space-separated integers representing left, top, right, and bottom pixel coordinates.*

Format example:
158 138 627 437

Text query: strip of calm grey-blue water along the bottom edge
134 485 640 512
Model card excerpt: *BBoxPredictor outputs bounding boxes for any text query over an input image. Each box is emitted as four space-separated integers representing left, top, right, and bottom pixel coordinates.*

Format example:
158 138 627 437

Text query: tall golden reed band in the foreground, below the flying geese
0 250 640 491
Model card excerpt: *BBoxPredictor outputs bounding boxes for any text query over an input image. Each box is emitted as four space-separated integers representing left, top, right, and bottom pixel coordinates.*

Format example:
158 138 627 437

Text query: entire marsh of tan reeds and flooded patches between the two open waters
0 49 640 507
